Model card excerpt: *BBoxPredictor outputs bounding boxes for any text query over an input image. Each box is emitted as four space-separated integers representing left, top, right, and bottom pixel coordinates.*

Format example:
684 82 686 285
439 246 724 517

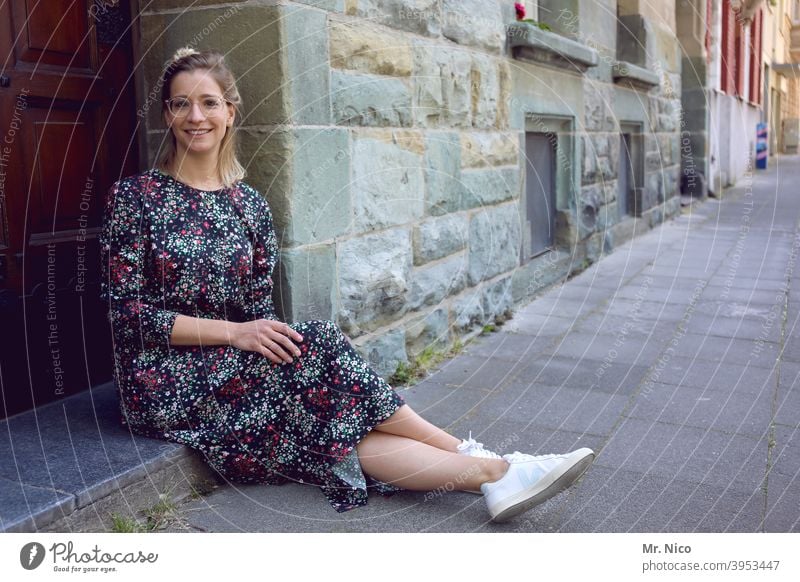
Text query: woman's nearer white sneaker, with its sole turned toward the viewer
481 447 594 523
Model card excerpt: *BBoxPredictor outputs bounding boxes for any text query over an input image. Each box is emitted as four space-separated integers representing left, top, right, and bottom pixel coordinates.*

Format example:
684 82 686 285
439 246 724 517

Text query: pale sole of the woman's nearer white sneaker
492 448 594 523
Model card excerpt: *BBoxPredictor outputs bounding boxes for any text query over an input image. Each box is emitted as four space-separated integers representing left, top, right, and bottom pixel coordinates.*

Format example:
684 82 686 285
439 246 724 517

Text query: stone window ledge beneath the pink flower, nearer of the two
506 22 600 73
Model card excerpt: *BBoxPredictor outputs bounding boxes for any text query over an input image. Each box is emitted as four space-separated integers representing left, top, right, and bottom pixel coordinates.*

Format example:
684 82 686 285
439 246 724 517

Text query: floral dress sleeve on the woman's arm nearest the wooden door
99 182 178 349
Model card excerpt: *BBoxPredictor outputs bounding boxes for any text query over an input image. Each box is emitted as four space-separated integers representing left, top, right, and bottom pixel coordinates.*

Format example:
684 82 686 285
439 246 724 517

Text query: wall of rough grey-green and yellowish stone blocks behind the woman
136 0 680 376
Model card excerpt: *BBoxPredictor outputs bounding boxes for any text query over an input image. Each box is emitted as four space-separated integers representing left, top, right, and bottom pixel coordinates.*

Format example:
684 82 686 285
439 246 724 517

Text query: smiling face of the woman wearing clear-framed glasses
164 70 235 162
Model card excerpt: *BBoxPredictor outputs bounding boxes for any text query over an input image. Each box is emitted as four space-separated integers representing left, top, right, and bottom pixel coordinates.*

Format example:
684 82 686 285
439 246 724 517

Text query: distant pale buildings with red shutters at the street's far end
678 0 800 196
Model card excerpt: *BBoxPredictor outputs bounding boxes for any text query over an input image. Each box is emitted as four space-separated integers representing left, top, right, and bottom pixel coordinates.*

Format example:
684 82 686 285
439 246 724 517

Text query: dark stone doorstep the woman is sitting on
0 382 221 532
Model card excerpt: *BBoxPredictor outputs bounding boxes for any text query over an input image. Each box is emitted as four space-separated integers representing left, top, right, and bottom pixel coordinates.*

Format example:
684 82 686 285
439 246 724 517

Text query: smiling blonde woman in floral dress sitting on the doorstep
100 49 594 521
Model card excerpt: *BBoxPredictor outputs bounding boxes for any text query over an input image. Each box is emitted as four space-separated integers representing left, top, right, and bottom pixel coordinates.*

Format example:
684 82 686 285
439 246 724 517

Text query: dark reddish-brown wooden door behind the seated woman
0 0 139 416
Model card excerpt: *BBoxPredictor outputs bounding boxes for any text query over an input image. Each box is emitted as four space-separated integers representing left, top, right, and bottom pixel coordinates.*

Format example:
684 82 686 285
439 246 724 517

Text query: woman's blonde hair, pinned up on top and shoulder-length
158 47 245 188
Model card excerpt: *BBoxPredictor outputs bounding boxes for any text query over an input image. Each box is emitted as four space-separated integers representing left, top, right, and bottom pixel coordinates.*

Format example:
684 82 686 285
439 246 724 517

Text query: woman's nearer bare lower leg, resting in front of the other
356 431 508 491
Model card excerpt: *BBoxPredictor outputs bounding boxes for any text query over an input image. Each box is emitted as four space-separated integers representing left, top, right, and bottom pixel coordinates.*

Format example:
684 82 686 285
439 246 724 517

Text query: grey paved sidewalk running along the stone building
161 157 800 532
